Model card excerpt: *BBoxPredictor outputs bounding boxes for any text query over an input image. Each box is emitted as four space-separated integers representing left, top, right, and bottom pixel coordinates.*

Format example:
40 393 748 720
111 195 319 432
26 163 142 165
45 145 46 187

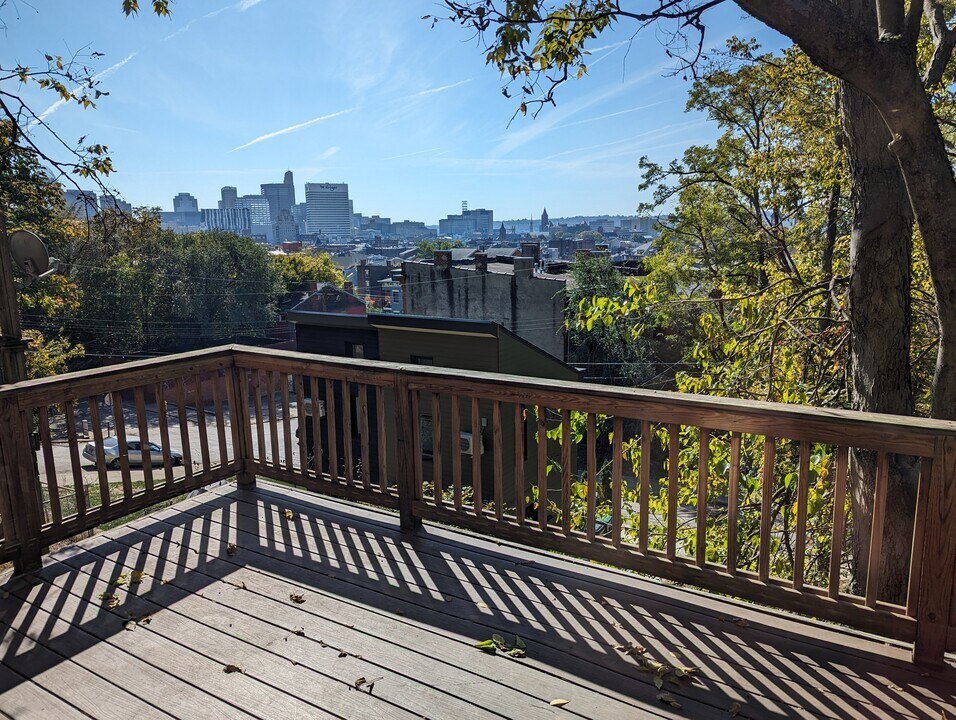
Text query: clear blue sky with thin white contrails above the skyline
0 0 780 224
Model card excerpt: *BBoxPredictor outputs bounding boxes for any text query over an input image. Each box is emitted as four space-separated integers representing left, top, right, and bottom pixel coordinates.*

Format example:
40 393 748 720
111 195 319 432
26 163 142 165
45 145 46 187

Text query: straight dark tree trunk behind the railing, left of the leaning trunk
840 83 918 602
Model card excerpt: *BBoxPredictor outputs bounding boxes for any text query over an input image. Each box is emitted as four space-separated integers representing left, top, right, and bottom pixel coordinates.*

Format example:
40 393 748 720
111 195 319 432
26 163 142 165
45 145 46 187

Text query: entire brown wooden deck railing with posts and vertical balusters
0 346 956 663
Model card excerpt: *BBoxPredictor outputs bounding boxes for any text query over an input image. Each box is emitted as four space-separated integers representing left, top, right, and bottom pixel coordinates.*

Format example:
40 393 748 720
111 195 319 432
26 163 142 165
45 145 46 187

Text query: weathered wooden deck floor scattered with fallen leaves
0 480 956 720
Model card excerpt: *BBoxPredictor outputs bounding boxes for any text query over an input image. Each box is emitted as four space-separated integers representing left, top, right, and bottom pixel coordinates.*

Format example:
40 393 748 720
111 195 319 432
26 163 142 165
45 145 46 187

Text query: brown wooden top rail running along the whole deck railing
0 345 956 457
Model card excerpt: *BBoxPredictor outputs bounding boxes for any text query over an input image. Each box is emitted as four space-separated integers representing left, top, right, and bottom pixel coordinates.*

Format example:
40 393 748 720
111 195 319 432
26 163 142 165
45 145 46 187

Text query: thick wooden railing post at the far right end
913 437 956 666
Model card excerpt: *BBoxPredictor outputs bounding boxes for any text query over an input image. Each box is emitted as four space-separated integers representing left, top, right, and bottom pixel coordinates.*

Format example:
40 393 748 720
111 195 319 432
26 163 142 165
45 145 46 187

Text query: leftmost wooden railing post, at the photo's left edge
0 399 42 573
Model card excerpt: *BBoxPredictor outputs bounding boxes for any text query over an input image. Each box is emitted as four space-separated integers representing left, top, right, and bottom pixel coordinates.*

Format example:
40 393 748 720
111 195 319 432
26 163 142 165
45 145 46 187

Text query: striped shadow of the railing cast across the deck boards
0 486 956 718
